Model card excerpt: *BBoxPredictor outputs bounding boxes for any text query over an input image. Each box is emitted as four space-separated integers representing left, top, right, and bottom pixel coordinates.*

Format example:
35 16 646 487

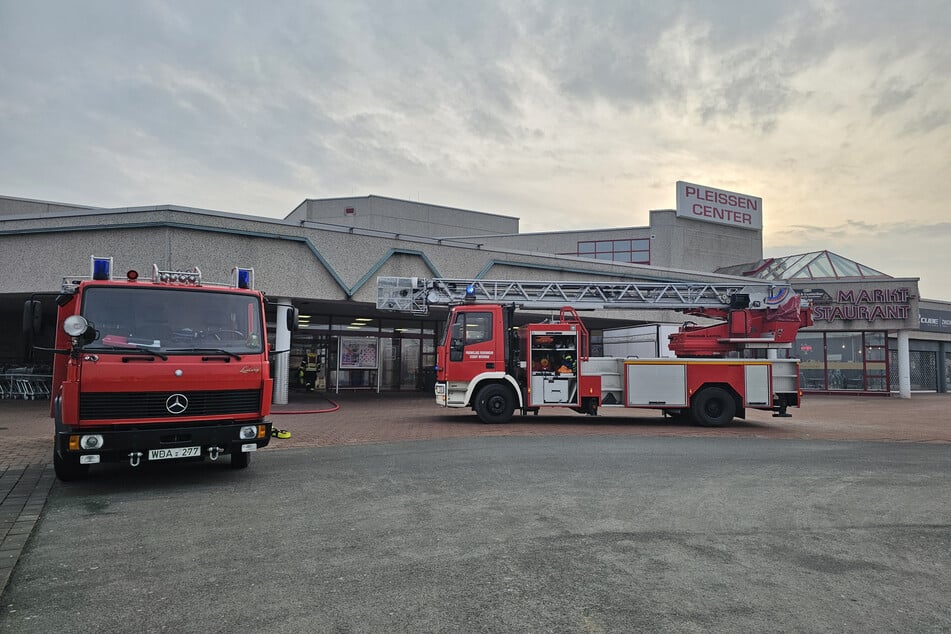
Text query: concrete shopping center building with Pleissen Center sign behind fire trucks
0 182 951 398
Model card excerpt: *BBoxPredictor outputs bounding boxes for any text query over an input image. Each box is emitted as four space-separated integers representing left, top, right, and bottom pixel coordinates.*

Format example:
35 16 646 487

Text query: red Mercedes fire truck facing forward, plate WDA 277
24 257 272 480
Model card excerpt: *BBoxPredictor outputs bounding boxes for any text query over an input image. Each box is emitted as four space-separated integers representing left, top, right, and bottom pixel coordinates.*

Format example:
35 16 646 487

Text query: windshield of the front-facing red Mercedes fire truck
82 286 264 354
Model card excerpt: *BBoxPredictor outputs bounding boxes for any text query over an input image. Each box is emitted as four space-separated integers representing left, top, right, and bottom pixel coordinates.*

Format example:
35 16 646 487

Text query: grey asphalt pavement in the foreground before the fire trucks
0 435 951 633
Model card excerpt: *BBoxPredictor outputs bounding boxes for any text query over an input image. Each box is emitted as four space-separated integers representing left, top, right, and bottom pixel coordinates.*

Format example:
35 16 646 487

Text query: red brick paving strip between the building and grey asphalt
0 393 951 469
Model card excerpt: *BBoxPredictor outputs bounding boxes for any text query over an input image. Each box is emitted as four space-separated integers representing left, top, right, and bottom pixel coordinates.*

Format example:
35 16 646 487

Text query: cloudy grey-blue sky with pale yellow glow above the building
0 0 951 300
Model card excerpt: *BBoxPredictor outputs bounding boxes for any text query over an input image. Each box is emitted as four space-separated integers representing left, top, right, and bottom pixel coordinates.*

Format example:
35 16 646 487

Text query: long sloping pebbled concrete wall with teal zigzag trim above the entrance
0 207 760 303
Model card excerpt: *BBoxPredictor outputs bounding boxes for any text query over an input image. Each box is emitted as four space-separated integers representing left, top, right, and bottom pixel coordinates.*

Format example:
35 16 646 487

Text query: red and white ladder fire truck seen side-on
377 278 812 426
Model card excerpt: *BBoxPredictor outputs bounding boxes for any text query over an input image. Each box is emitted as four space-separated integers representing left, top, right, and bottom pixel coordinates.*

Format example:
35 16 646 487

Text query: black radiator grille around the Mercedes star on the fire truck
79 390 261 420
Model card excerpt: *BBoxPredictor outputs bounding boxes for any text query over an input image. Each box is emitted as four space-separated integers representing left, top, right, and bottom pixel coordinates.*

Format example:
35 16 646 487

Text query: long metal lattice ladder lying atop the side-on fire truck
376 277 792 314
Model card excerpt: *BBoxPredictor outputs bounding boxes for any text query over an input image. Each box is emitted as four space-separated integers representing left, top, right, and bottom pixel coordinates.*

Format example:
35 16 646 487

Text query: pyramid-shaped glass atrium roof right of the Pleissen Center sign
716 251 891 280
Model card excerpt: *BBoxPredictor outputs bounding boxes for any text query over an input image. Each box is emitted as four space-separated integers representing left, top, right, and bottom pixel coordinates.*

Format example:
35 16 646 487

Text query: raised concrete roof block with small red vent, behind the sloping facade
286 196 518 238
